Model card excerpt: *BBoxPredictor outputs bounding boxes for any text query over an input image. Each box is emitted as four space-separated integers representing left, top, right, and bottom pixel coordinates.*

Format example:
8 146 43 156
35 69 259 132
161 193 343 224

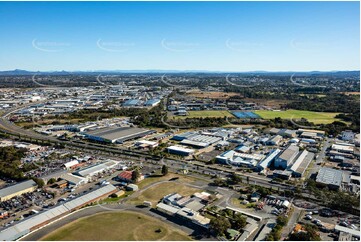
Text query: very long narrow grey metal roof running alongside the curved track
0 184 116 241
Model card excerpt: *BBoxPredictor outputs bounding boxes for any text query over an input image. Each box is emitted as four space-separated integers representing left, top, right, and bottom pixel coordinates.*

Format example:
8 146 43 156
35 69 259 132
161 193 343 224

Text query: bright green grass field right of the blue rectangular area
254 109 339 124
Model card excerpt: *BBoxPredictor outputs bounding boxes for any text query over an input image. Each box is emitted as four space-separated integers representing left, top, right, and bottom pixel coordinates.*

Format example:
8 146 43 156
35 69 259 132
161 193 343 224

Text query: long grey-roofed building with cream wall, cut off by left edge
0 180 38 202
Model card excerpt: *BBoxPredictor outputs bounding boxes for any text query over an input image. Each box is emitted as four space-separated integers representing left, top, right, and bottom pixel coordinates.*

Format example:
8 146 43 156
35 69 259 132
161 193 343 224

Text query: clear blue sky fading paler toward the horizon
0 1 360 72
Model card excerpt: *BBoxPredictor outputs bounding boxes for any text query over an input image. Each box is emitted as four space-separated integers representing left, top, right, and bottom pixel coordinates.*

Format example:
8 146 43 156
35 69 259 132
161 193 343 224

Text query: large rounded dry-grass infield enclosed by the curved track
41 212 191 241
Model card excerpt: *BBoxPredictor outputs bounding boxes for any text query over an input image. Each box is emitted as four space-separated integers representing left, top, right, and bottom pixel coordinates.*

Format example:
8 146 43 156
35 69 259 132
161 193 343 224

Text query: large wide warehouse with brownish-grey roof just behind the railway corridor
83 127 155 143
